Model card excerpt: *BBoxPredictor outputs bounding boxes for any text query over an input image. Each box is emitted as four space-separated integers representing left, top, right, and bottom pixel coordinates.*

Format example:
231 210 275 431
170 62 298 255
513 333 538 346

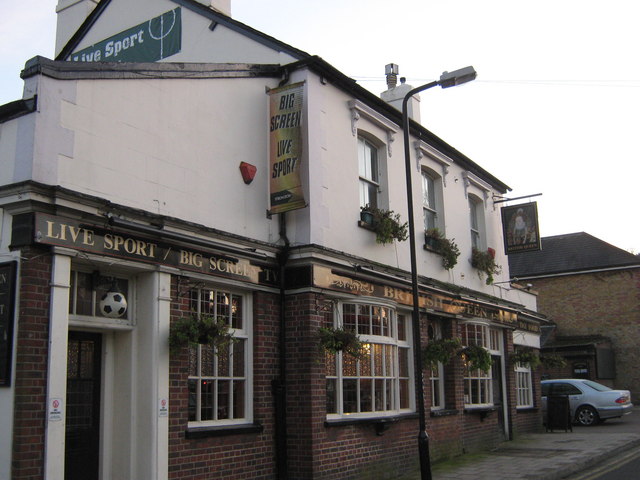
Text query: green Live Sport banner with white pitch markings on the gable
68 8 182 62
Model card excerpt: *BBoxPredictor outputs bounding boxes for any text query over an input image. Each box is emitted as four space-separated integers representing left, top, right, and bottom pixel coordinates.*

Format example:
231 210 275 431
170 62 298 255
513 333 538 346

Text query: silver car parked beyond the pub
542 378 633 426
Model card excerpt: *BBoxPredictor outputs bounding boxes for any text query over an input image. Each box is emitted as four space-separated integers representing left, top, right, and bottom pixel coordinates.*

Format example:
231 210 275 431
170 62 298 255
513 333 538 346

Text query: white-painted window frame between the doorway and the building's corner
186 285 253 428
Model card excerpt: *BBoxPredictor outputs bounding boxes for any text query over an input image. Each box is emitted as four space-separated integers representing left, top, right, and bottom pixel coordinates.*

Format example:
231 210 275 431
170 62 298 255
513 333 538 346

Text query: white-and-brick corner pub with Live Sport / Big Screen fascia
0 0 546 480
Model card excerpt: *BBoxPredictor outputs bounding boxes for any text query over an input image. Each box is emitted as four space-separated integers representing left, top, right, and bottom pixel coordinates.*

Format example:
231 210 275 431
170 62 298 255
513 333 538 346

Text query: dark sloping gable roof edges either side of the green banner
55 0 310 61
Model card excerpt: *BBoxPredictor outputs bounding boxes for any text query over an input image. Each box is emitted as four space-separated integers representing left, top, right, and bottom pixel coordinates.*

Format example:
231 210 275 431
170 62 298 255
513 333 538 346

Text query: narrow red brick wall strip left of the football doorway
11 247 51 480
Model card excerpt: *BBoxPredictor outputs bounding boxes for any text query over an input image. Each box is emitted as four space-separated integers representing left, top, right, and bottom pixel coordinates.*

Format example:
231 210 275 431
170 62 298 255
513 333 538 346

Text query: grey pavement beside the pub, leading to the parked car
432 405 640 480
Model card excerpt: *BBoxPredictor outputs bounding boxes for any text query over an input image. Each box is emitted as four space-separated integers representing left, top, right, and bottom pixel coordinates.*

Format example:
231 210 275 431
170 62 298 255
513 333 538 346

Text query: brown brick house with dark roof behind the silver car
509 232 640 399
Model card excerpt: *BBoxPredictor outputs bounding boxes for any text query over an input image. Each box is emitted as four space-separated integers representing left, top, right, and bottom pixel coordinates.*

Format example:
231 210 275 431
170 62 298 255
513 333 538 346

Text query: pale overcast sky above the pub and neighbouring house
0 0 640 253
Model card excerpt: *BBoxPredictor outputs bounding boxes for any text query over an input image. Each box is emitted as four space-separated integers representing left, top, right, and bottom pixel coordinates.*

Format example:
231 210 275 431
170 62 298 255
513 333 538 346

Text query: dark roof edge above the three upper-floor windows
282 55 512 193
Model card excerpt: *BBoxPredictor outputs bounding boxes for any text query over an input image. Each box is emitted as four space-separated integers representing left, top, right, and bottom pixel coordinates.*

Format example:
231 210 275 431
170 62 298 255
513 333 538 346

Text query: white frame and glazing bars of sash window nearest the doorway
187 285 253 428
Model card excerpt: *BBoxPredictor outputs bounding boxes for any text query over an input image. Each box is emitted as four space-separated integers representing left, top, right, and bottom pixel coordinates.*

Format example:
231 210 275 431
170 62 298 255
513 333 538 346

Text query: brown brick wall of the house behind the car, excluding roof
532 269 640 399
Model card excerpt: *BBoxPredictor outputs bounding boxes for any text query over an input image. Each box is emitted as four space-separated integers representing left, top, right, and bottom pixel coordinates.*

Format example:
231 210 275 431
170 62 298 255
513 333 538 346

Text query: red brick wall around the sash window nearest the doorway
169 284 279 480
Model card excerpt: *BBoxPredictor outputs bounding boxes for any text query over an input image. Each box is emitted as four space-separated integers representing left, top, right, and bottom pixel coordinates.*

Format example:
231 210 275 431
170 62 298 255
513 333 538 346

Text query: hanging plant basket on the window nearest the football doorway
169 314 236 353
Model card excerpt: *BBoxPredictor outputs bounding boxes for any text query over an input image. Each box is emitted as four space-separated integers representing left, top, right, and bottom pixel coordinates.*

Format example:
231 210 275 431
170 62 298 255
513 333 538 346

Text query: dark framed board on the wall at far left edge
0 262 16 387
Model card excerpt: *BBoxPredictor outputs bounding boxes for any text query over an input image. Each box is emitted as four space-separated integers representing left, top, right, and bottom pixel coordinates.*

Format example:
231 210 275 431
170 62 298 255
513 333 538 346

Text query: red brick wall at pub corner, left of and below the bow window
287 294 418 480
